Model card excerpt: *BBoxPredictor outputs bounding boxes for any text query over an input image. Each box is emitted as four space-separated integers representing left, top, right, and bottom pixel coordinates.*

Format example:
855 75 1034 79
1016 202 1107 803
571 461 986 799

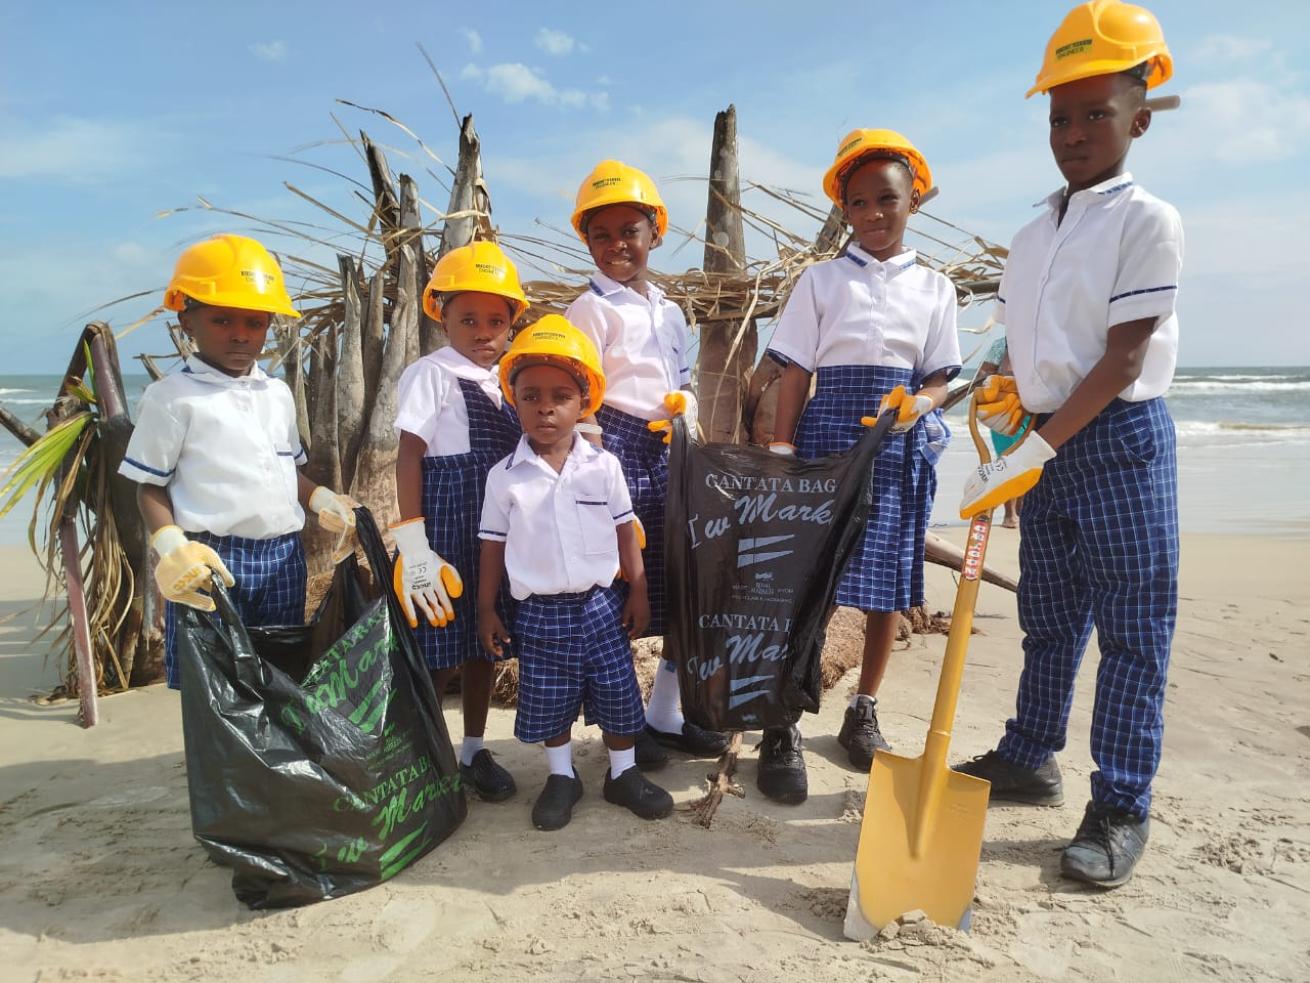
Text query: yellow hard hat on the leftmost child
164 233 300 317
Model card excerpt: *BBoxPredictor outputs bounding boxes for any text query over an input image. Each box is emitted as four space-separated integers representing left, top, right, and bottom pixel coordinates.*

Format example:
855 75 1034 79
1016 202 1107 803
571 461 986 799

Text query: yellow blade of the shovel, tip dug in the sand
845 751 992 940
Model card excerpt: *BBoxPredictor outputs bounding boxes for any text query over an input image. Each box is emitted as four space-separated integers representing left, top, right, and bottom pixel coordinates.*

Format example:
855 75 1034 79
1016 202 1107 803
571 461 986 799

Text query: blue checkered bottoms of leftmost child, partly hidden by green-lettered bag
164 532 307 689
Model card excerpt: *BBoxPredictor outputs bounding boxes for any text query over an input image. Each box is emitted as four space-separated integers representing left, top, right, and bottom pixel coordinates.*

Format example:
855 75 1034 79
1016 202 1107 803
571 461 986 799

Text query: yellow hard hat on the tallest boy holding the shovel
1024 0 1174 98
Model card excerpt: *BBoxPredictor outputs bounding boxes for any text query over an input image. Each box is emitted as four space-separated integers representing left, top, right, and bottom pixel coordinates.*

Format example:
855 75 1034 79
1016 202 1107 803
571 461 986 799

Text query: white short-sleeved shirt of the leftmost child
118 358 305 539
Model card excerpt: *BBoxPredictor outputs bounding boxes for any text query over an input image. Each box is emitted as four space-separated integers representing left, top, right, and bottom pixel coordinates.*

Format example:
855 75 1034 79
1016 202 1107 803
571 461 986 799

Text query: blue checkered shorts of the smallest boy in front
514 587 646 744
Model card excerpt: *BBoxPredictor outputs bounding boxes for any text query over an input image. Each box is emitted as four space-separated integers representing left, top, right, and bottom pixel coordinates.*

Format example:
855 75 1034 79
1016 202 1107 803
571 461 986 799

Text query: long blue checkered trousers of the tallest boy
998 398 1178 818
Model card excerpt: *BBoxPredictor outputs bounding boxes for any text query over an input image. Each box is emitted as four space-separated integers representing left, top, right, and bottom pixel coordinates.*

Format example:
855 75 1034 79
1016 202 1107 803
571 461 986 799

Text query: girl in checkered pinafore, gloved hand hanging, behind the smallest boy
392 242 528 802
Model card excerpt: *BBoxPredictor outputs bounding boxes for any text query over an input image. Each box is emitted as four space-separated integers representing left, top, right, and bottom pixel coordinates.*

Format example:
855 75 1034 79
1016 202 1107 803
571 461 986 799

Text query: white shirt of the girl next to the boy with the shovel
769 242 960 379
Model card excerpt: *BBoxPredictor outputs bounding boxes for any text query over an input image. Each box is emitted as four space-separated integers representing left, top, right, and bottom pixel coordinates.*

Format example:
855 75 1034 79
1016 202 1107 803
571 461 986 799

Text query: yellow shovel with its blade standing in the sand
845 393 1031 940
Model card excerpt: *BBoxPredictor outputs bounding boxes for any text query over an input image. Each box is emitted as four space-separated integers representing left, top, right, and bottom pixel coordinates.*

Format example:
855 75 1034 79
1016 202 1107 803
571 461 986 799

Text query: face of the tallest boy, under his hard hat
1051 75 1150 191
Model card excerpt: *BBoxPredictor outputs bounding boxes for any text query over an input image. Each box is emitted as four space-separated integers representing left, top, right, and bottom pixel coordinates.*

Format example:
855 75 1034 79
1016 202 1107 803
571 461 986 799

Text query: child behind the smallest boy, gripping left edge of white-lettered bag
565 160 727 768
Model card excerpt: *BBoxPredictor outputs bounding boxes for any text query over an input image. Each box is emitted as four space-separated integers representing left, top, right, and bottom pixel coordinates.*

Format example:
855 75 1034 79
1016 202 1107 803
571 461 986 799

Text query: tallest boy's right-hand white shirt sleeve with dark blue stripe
1107 201 1183 326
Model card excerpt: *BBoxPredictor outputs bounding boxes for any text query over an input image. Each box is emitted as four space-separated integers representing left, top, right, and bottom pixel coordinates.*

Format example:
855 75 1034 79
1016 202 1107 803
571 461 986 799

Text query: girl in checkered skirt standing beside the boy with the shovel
757 130 960 802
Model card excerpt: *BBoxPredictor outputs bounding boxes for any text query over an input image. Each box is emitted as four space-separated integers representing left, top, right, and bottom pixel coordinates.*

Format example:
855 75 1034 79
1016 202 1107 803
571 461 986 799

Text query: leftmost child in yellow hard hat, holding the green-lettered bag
119 235 355 689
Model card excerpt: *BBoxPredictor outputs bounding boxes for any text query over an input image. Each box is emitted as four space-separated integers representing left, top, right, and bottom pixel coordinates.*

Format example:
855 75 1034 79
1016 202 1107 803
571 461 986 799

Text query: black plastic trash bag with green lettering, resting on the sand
178 509 468 908
